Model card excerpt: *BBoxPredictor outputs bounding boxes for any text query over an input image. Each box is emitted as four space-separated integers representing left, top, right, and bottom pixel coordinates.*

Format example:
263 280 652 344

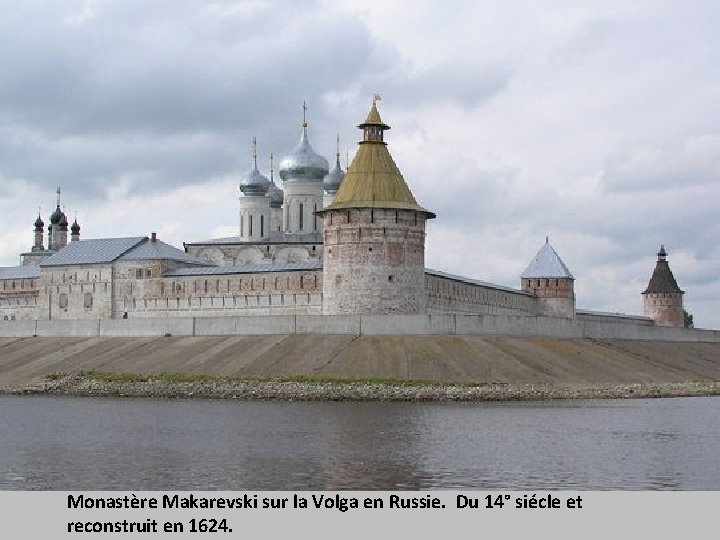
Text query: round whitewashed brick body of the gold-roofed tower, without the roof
323 208 427 314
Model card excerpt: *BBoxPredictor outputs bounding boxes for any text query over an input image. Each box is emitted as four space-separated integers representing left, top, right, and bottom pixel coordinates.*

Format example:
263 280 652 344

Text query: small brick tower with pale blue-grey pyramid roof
520 238 575 318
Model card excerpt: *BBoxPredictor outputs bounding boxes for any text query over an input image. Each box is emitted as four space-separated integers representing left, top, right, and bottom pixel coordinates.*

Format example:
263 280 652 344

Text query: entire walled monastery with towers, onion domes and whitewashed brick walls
0 101 684 326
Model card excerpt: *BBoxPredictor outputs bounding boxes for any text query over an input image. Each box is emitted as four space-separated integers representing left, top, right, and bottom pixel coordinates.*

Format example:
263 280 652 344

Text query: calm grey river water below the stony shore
0 396 720 491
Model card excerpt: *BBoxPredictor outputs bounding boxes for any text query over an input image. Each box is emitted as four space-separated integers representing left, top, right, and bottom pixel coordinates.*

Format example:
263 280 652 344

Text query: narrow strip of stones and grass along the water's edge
0 372 720 402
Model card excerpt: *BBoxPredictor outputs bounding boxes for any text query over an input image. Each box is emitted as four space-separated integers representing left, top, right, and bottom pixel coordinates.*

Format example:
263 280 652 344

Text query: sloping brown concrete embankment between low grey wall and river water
0 334 720 400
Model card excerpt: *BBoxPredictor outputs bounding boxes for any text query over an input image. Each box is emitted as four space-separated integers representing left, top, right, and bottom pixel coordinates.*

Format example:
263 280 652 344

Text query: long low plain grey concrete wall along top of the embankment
0 315 720 343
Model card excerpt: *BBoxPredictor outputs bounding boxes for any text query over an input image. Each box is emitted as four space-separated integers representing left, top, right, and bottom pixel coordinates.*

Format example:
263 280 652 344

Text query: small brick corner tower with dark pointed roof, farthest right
642 245 685 327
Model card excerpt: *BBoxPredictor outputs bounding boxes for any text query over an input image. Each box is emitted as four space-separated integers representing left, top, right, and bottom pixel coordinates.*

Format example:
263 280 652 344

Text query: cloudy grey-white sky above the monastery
0 0 720 328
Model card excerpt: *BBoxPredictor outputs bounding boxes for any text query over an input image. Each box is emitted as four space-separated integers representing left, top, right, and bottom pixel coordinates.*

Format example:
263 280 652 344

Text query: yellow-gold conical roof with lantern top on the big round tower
318 96 435 218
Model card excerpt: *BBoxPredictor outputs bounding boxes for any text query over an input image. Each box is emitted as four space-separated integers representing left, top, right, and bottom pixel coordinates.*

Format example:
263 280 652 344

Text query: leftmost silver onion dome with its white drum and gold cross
240 137 270 241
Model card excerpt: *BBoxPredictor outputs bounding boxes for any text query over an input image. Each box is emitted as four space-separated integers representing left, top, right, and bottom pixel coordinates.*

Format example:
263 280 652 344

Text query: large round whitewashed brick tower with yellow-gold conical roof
318 96 435 315
